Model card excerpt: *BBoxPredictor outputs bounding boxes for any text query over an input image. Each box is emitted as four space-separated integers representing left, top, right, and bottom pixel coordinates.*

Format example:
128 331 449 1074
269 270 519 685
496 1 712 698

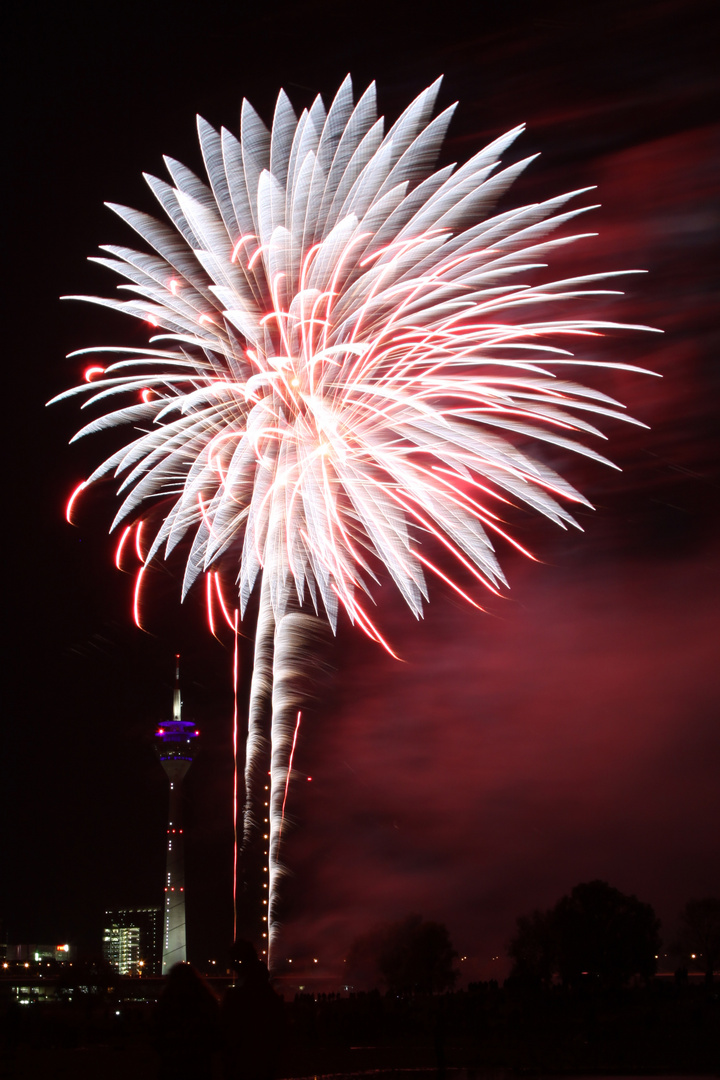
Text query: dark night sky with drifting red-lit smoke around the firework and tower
5 0 720 977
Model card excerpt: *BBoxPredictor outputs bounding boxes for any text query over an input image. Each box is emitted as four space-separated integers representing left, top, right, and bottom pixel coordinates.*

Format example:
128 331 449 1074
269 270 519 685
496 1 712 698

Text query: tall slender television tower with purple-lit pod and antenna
155 656 200 975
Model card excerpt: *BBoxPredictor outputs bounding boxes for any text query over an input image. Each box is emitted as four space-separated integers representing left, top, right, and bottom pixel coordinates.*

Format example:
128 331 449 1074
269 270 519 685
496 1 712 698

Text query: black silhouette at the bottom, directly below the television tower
154 963 219 1080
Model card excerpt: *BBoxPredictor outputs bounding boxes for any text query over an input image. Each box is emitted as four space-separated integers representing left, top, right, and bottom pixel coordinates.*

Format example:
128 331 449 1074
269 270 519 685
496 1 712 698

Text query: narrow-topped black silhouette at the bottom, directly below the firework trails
220 941 284 1080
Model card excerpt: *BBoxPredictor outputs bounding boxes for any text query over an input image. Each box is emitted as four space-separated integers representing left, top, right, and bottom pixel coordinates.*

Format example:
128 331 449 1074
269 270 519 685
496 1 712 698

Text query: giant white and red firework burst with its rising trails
50 77 650 972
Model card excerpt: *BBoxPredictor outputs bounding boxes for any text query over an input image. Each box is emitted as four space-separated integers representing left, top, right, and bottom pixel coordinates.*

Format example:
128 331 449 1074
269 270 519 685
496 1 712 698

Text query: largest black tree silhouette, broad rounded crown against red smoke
507 881 660 987
